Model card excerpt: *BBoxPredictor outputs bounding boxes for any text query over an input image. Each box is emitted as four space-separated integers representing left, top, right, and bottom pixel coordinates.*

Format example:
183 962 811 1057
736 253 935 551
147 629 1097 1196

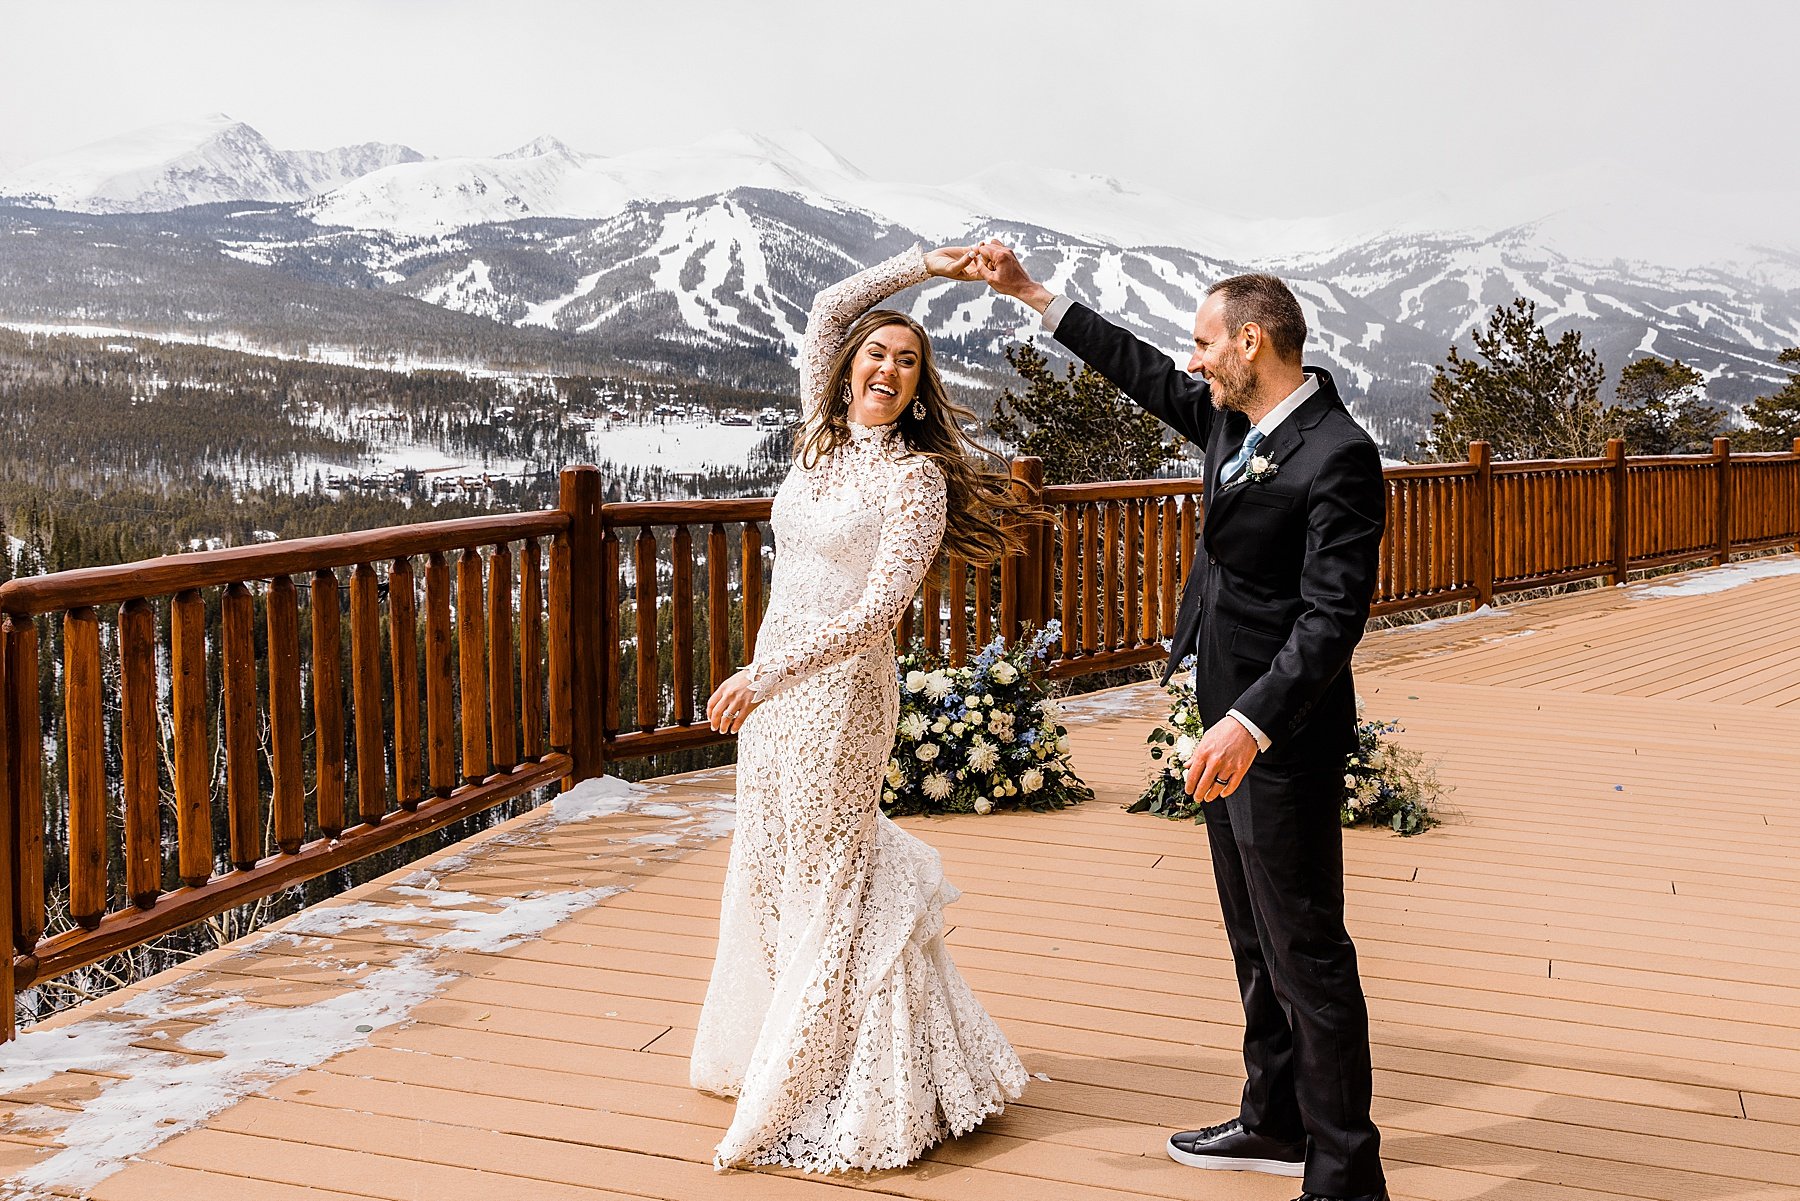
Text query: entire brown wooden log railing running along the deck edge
0 439 1800 1041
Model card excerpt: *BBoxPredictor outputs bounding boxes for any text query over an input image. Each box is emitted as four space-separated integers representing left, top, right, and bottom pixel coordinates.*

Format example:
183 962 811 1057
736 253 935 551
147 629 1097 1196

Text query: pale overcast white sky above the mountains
0 0 1800 216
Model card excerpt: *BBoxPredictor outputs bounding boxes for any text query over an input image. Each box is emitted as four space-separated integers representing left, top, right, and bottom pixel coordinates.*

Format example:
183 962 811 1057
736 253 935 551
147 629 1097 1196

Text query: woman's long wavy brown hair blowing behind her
794 308 1037 567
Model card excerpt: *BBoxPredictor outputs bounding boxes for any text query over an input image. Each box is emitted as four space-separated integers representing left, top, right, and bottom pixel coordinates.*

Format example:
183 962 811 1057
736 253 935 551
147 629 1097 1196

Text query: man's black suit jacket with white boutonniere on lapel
1055 304 1386 762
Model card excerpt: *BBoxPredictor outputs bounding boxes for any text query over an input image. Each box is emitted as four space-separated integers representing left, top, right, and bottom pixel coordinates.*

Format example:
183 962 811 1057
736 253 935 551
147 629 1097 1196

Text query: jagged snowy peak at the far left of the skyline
0 113 421 212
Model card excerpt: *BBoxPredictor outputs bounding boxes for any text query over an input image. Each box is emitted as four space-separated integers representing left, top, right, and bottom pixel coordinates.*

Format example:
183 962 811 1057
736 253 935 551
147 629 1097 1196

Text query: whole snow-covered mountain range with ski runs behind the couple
0 117 1800 450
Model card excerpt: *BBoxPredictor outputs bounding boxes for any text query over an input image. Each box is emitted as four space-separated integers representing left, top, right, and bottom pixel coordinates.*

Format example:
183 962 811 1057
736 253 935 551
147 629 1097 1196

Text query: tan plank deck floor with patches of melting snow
0 558 1800 1201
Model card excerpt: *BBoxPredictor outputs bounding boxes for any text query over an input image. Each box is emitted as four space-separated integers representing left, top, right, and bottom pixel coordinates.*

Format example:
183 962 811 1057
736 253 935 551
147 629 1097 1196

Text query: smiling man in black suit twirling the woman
981 241 1388 1201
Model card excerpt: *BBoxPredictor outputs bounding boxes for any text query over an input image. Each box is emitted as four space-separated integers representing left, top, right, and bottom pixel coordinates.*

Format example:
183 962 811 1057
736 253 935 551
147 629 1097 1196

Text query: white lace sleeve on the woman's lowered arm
745 459 947 702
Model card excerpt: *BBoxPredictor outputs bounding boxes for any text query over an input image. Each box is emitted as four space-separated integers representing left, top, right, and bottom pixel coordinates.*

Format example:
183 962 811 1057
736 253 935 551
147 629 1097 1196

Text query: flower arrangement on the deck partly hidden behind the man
1130 681 1444 835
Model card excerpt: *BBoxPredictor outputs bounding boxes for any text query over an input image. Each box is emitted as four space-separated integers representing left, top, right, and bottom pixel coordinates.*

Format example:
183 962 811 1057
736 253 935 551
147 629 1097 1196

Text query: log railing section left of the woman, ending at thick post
0 468 599 1039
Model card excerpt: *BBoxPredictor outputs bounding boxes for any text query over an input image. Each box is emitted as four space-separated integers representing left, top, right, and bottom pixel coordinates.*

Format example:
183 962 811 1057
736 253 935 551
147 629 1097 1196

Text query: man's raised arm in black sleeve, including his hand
981 241 1213 447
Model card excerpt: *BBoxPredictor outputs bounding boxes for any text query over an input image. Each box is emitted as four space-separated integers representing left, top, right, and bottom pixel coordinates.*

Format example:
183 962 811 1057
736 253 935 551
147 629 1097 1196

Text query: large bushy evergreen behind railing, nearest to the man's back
1420 297 1611 461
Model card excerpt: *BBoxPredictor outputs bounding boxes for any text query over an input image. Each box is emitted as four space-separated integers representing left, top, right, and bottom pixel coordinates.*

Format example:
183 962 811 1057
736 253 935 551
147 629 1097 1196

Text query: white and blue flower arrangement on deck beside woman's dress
882 621 1093 817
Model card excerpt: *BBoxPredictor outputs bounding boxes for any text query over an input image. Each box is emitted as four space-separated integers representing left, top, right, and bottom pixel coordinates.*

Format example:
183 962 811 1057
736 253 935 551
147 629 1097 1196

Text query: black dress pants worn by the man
1206 754 1384 1197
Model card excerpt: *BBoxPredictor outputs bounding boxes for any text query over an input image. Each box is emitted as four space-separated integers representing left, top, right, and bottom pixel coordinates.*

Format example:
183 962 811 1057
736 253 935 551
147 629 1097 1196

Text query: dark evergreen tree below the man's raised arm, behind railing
988 344 1181 484
